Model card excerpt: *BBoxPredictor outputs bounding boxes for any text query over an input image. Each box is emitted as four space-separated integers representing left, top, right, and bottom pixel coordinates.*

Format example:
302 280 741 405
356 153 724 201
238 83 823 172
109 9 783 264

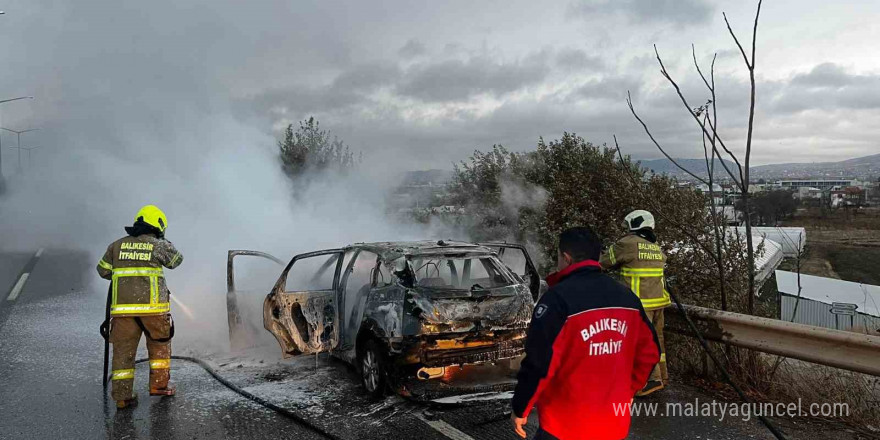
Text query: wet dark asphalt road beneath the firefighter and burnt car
0 249 857 440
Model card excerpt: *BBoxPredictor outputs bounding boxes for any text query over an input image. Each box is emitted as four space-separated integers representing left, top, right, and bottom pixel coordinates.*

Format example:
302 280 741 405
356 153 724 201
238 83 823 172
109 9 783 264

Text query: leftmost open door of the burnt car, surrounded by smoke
226 250 284 350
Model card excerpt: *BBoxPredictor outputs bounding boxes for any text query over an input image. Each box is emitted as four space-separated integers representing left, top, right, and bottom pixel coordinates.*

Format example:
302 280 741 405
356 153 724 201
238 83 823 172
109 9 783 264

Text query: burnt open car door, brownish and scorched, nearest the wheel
263 249 344 357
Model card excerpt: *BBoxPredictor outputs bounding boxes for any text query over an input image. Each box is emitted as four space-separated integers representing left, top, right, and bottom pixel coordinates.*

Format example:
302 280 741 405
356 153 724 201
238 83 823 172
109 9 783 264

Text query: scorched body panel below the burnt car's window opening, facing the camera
408 284 534 333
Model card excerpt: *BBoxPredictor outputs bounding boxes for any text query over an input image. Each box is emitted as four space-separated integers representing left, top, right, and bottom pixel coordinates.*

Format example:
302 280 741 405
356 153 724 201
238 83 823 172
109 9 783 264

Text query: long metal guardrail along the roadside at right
667 305 880 376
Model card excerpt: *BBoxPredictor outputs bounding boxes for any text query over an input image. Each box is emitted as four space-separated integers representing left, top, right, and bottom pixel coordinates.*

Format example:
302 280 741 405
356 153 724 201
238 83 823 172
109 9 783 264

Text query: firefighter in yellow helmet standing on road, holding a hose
98 205 183 408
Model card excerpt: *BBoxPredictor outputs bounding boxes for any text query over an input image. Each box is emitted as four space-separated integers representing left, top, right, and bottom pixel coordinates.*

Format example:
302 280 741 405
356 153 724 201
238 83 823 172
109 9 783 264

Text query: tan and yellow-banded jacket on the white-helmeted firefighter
599 234 670 310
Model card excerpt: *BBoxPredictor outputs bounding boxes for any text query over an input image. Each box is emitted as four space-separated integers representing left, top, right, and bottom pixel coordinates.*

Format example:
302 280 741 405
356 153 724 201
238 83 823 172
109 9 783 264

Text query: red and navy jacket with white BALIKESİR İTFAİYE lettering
512 260 660 440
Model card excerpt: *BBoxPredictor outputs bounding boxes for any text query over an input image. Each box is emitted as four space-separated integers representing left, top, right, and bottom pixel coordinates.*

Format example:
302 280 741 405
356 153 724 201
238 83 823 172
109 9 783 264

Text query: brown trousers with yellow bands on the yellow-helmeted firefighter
110 314 172 400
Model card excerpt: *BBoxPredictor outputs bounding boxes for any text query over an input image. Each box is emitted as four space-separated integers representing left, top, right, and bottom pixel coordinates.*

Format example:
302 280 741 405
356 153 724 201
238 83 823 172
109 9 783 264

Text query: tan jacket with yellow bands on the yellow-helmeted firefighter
98 234 183 316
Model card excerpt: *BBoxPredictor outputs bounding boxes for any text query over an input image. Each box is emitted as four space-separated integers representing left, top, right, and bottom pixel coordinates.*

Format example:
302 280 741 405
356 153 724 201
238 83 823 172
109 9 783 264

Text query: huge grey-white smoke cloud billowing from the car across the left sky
0 1 440 349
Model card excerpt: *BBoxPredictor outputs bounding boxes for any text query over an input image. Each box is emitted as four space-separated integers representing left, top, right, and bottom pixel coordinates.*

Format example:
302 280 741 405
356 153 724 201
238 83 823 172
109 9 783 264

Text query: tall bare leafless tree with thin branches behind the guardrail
626 0 763 313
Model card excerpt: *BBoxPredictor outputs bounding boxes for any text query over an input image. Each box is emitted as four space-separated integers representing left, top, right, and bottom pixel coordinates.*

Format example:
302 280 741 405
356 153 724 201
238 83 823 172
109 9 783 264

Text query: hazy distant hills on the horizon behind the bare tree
641 154 880 180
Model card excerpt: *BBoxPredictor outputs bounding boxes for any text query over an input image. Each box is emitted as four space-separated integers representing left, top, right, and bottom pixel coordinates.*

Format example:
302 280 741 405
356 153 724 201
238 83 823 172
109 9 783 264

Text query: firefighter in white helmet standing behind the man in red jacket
599 210 670 396
